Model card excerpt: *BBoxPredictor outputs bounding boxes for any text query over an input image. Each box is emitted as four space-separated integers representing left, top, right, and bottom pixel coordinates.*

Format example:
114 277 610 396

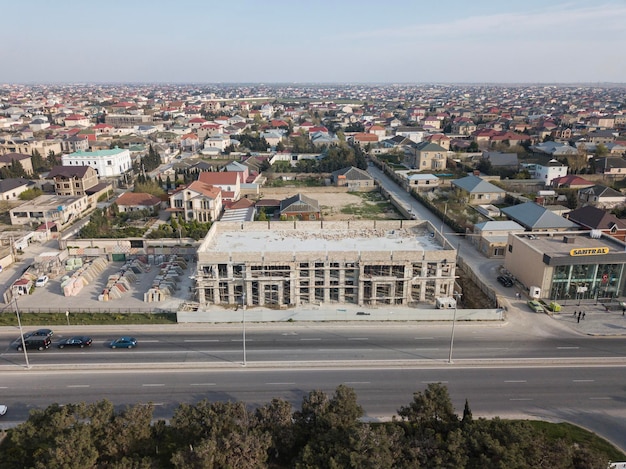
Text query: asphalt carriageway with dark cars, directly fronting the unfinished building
0 323 626 369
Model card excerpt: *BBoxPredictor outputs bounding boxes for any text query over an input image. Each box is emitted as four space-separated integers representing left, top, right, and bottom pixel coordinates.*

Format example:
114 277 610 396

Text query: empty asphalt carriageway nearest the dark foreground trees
0 364 626 448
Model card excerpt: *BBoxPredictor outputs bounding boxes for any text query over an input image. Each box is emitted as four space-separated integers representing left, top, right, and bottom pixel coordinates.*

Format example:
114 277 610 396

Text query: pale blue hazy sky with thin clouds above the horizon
0 0 626 83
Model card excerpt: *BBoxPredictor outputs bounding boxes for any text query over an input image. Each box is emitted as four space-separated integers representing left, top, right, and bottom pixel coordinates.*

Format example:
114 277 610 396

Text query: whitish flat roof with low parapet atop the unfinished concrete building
205 221 444 252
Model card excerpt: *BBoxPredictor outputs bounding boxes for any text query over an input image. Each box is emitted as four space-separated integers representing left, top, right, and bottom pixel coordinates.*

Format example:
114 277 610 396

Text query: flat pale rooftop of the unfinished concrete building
206 224 444 253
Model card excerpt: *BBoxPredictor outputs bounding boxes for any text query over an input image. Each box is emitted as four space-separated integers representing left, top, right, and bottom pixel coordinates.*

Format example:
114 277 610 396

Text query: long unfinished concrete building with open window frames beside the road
196 220 456 308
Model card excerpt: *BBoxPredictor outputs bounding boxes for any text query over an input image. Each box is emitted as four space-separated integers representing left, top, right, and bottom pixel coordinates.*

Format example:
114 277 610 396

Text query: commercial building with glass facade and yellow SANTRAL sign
504 230 626 302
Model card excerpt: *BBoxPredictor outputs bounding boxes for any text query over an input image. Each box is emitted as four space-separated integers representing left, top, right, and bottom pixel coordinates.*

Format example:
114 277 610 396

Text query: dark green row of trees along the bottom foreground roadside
0 384 609 469
